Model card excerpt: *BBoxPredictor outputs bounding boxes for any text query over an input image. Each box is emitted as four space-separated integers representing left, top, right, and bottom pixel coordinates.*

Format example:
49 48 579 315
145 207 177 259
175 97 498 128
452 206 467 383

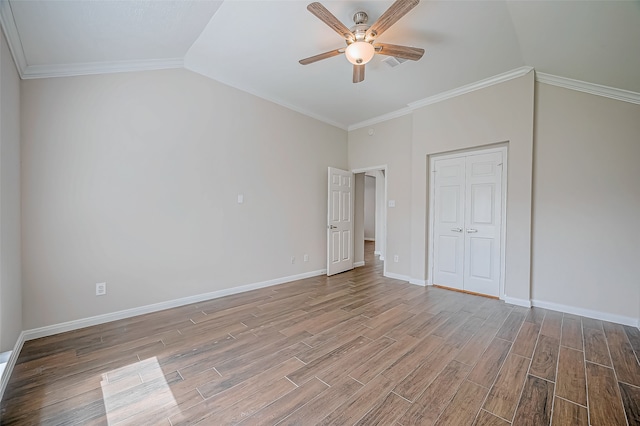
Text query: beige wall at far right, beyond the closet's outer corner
532 84 640 319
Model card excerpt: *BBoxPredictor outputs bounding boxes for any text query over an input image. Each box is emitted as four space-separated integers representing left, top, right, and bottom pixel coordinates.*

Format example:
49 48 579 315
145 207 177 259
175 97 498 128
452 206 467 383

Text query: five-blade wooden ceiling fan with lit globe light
299 0 424 83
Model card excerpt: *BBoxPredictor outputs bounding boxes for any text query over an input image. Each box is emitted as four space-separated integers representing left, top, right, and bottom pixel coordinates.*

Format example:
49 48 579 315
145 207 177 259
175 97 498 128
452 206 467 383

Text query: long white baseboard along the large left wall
23 269 327 341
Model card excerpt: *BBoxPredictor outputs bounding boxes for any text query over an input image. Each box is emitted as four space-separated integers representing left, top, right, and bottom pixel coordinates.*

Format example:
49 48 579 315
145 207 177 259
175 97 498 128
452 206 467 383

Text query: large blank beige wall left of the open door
22 70 347 329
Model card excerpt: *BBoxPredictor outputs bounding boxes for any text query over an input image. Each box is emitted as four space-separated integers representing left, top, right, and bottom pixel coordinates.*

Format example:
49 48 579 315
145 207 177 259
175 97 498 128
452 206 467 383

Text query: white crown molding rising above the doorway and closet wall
347 67 533 131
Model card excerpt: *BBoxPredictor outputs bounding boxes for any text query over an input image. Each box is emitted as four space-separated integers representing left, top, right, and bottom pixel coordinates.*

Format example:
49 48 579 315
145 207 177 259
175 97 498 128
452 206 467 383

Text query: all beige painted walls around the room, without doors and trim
11 62 640 332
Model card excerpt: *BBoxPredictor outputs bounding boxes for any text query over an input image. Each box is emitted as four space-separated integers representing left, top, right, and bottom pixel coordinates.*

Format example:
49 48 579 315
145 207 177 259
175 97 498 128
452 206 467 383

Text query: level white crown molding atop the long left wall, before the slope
21 58 184 79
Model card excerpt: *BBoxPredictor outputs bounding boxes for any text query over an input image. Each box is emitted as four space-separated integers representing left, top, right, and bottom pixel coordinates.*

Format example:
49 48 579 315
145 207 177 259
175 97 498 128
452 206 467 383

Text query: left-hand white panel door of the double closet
433 157 465 290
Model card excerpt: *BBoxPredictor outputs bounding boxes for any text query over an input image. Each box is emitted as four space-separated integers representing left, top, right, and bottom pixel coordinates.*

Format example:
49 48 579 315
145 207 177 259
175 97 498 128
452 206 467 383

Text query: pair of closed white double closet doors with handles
433 151 503 296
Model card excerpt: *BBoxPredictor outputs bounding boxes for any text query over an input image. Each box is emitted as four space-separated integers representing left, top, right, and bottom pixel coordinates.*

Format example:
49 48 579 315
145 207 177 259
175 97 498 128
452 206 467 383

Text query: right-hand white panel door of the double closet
464 152 502 297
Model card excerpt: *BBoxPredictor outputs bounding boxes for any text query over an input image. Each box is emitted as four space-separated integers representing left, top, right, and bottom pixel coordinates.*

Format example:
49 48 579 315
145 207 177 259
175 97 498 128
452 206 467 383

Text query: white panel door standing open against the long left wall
327 167 354 275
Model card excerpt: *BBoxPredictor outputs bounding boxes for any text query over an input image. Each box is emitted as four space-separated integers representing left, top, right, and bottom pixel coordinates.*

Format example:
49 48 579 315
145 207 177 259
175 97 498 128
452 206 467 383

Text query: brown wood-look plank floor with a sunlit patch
0 244 640 426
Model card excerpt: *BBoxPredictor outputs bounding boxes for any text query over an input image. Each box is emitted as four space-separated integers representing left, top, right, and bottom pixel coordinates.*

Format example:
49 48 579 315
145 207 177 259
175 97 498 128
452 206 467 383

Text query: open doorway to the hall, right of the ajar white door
353 166 387 272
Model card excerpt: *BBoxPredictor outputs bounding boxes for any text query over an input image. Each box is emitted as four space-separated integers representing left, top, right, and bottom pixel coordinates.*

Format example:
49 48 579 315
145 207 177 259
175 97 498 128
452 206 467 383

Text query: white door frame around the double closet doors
427 143 509 300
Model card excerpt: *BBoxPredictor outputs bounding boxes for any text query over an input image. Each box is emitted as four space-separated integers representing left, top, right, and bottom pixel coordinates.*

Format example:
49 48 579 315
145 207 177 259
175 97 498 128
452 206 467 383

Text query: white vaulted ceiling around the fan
0 0 640 128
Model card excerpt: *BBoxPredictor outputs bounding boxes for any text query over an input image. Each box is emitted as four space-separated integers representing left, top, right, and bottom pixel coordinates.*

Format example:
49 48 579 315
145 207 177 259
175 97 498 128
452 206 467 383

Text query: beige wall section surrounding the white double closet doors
410 71 534 302
